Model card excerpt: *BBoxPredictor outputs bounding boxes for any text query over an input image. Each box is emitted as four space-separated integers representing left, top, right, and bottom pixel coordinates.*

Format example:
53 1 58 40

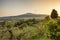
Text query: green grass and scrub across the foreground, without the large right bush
0 19 60 40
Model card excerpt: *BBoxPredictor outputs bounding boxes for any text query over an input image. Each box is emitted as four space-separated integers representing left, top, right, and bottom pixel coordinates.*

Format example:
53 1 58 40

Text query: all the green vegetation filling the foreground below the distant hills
0 18 60 40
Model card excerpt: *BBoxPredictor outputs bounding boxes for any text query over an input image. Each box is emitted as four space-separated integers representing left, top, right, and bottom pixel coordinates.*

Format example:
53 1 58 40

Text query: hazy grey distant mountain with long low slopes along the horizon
0 13 47 20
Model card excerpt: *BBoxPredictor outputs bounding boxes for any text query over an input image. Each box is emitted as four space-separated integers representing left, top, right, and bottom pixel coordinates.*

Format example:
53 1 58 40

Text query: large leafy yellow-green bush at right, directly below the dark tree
47 20 58 40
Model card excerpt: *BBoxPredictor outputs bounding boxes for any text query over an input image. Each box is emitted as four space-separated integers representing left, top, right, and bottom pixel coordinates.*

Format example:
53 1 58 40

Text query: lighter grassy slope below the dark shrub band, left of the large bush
0 20 59 40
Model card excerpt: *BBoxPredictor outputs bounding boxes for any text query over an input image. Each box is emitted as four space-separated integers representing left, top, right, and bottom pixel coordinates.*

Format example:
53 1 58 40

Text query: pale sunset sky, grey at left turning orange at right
0 0 60 17
